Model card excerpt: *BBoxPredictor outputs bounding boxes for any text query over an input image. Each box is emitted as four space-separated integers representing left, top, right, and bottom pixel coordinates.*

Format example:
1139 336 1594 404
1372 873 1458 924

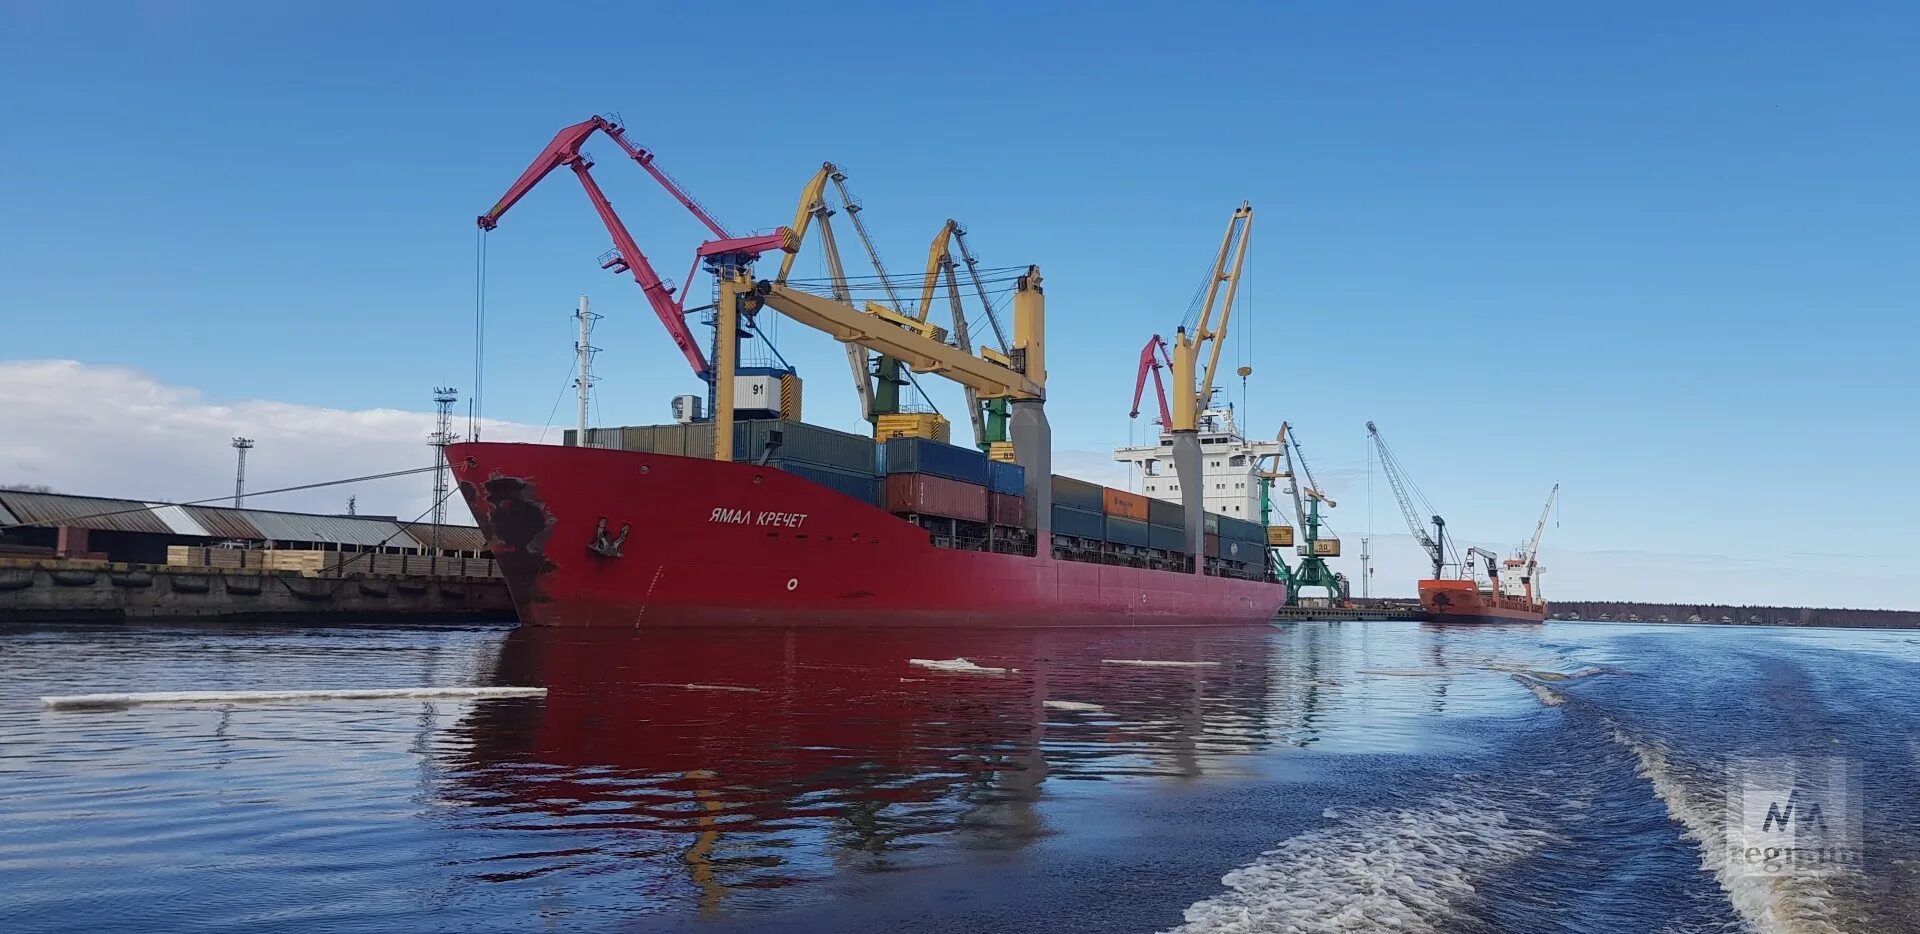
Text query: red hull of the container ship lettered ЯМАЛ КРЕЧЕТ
447 442 1286 628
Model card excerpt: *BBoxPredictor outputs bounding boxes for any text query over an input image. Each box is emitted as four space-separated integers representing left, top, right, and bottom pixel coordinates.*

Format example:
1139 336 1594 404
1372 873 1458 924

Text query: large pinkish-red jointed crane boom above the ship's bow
476 115 789 379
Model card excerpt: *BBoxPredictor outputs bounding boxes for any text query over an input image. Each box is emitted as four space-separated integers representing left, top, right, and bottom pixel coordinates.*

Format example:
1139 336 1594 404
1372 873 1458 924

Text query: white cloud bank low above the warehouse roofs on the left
0 359 540 523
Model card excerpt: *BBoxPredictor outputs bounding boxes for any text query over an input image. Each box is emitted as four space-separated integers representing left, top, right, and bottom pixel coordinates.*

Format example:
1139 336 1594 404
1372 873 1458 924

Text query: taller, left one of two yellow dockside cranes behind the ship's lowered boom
774 161 947 440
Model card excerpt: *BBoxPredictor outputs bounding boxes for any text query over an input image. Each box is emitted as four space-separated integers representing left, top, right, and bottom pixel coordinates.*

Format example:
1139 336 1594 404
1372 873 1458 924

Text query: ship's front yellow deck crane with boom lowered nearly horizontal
712 263 1054 530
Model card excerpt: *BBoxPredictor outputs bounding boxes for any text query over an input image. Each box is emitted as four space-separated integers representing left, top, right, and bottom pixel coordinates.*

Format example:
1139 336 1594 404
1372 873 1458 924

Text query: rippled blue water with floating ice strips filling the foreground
0 623 1920 932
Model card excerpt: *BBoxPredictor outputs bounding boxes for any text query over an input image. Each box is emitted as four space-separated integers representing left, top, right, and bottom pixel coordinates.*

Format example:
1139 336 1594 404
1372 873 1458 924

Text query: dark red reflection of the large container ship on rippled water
444 628 1282 907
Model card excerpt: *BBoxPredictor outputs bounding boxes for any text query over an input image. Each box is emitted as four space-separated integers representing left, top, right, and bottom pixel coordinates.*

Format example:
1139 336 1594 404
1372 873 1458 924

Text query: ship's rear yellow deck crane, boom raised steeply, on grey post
1167 202 1254 573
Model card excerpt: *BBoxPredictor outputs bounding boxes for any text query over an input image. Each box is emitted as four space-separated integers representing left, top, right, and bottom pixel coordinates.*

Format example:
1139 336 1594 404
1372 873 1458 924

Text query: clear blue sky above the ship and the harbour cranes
0 2 1920 605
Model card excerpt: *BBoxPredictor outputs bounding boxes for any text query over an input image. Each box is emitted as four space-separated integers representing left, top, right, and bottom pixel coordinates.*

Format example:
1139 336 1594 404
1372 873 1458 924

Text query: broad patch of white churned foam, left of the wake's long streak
1171 796 1549 934
